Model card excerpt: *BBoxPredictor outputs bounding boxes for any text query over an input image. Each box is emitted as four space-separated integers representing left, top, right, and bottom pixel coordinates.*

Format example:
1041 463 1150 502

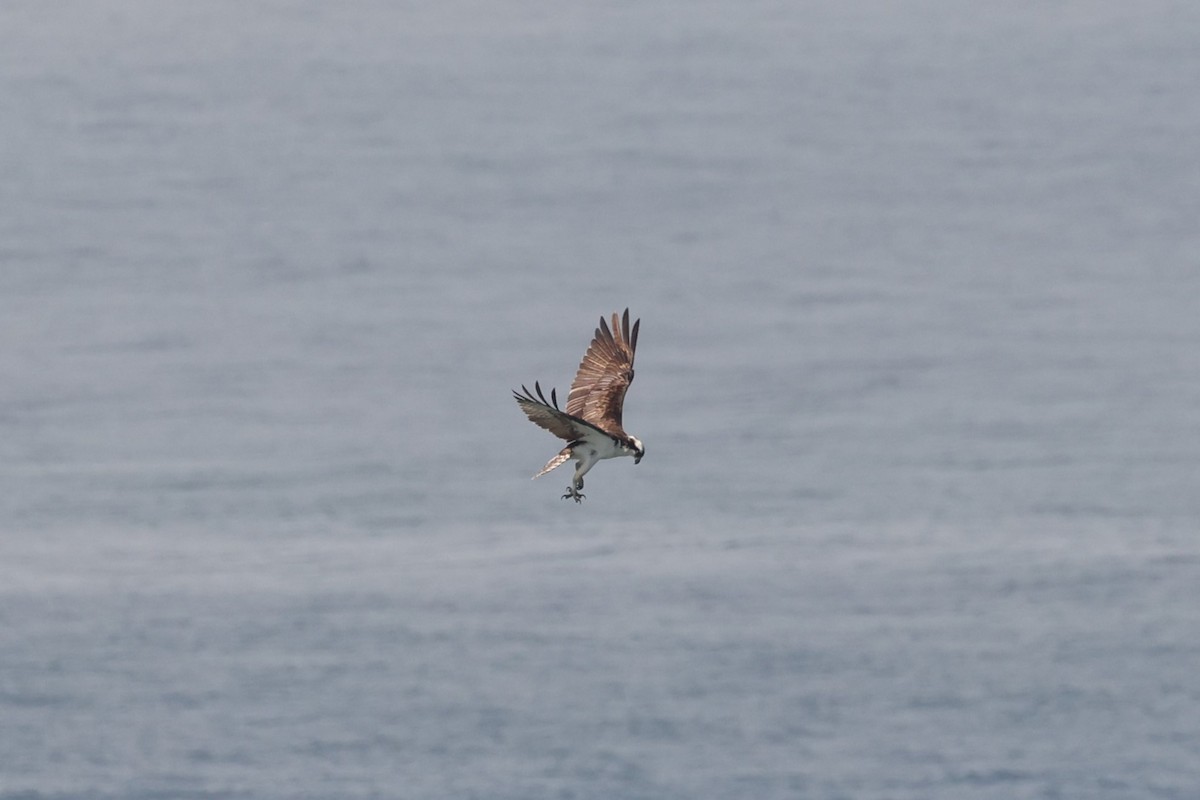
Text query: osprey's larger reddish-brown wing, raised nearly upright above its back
566 308 642 435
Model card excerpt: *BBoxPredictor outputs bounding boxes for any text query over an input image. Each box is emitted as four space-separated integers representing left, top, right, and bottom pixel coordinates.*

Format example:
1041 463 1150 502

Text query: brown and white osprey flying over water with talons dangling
512 308 646 503
